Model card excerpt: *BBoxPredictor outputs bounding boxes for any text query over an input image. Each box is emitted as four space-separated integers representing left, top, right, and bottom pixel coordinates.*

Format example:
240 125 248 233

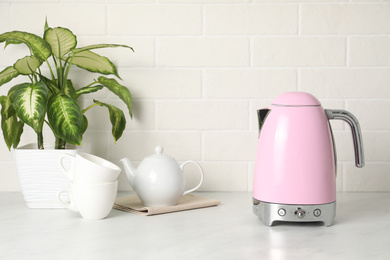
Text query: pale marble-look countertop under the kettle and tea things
0 192 390 260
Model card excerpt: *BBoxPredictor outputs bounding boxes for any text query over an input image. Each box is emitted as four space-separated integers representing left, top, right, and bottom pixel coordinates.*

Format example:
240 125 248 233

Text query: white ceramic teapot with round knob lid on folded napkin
121 146 203 207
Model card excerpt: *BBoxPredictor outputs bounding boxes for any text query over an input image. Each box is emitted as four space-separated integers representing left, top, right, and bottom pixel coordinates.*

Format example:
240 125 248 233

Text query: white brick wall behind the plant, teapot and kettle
0 0 390 191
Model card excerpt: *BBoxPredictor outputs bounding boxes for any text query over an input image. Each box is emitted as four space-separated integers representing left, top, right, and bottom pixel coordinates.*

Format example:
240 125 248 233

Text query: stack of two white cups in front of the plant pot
57 153 121 219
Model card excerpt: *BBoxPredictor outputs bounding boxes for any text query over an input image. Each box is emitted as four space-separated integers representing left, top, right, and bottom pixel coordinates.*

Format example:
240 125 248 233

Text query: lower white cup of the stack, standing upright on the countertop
57 181 118 219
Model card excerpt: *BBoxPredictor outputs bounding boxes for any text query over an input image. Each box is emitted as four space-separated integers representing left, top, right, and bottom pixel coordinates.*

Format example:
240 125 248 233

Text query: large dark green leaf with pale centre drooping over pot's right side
47 95 84 145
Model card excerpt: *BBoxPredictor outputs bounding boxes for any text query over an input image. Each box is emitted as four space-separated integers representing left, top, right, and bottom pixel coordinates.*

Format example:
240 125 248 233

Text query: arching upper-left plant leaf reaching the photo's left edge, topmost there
0 31 51 61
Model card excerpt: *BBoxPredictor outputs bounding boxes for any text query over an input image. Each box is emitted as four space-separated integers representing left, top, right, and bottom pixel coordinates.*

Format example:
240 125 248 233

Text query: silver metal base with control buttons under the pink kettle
253 198 336 227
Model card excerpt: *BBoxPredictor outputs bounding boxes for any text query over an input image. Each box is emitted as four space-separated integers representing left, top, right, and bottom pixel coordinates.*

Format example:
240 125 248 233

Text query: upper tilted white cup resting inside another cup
59 153 121 184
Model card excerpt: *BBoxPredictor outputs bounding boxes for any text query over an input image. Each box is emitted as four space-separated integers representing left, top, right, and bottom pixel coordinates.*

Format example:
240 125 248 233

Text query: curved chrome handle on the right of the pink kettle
325 109 364 168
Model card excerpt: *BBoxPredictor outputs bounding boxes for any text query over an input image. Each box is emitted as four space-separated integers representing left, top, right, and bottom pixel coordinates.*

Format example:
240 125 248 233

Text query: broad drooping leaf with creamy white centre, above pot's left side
11 82 48 133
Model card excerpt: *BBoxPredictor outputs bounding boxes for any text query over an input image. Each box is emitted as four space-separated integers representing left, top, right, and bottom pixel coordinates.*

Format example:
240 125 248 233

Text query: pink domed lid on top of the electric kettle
272 92 321 106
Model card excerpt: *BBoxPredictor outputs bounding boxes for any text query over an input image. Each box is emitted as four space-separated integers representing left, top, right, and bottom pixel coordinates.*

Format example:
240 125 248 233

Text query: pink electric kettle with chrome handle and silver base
253 92 364 226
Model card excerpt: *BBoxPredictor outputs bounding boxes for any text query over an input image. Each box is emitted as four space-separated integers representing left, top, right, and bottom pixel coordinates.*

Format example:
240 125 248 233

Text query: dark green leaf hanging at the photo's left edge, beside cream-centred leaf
0 96 24 150
